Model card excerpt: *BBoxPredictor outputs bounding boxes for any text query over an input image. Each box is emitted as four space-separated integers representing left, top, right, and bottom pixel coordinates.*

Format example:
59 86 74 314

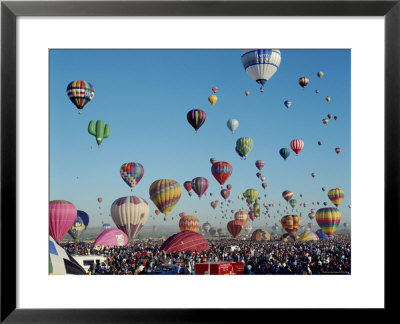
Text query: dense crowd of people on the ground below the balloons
62 235 351 275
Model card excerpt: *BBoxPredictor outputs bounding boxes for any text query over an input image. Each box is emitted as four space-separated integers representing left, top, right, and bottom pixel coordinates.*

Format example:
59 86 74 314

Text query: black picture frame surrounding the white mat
0 0 400 323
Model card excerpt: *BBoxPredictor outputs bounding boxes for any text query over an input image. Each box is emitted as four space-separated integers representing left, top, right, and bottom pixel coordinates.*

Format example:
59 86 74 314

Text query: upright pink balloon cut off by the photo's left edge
49 200 78 242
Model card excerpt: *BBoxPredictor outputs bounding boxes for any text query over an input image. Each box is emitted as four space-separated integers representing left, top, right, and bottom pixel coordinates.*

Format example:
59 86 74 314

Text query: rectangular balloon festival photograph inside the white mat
49 48 350 275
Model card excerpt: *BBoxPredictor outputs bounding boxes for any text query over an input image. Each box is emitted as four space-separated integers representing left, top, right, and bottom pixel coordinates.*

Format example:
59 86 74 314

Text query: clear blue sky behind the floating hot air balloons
49 49 351 231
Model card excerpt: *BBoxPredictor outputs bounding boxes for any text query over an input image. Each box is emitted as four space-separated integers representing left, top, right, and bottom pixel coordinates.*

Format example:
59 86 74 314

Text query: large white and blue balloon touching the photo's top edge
242 49 281 90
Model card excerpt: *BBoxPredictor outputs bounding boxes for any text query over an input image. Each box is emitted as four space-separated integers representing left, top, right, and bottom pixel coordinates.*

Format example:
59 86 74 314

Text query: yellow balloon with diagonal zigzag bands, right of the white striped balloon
149 179 182 216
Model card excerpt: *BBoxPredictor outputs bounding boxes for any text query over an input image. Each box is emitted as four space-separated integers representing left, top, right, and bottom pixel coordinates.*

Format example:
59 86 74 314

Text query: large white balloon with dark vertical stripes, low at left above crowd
111 196 150 240
